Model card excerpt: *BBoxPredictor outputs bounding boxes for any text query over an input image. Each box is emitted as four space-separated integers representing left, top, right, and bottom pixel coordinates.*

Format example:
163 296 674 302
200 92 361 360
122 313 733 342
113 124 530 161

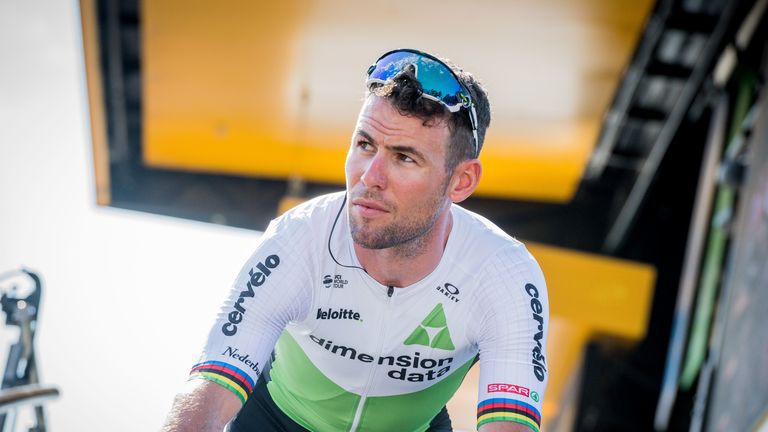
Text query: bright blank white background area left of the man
0 0 258 432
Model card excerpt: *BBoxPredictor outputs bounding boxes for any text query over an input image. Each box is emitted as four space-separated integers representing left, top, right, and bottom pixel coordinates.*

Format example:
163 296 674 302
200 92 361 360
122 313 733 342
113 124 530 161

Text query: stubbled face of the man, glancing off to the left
346 95 450 249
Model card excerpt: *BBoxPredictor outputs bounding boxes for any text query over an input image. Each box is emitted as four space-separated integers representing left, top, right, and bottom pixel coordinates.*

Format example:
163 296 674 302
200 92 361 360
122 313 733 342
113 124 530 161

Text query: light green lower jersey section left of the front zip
267 331 360 431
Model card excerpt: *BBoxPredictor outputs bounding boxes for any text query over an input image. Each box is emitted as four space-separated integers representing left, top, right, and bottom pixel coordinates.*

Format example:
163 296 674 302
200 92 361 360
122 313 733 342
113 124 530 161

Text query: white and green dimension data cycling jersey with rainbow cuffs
192 193 549 431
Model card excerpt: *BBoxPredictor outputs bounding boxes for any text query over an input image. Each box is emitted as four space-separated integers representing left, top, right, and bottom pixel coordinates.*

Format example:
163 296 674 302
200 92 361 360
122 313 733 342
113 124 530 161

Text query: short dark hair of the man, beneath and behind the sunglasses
368 59 491 173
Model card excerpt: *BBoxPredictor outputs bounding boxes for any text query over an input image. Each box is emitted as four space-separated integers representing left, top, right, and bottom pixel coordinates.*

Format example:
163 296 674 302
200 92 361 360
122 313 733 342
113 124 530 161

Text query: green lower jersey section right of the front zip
358 359 474 431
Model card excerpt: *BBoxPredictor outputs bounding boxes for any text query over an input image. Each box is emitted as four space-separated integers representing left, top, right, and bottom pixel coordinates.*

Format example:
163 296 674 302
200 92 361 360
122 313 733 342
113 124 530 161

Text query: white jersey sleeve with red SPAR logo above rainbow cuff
473 243 549 432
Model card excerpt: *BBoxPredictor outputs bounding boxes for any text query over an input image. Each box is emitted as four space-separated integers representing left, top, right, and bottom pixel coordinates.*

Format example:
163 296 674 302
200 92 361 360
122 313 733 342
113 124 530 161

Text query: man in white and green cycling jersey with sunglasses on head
165 50 549 432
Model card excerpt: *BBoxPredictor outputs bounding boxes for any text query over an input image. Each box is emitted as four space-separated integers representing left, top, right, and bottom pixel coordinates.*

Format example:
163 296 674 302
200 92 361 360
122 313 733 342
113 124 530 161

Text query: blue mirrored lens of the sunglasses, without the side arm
368 51 467 108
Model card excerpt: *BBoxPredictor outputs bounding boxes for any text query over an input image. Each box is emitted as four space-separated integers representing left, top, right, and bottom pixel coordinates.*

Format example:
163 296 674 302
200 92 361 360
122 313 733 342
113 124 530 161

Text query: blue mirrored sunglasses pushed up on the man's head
366 49 479 158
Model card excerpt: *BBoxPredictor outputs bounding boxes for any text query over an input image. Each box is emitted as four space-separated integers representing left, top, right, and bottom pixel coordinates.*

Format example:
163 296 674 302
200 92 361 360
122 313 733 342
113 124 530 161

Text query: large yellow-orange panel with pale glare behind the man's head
141 0 653 202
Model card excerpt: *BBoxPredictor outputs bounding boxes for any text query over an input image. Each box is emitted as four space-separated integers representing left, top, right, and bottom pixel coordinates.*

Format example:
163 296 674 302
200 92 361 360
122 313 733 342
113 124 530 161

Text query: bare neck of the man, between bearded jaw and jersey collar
354 205 453 287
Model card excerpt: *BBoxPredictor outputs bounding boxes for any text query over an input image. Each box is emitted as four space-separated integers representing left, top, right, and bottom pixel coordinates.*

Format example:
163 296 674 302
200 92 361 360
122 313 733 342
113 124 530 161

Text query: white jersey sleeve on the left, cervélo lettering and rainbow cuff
190 218 312 404
